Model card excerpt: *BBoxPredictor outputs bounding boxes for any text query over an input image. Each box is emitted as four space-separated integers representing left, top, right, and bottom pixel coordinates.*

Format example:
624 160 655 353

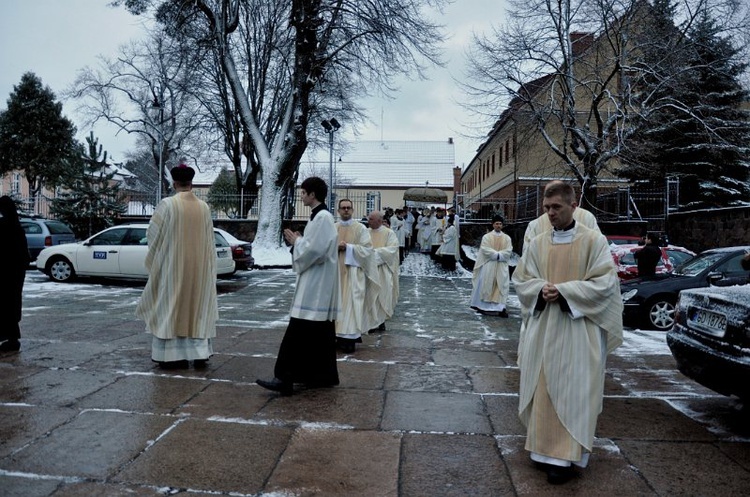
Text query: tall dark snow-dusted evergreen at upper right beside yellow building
620 5 750 209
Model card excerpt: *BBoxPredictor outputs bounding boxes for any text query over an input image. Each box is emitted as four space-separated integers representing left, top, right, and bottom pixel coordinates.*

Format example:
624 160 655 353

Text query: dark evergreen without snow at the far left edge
0 72 79 205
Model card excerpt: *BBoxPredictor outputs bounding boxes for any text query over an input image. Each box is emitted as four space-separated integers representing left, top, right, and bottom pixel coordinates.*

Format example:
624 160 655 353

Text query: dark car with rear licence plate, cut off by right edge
667 285 750 402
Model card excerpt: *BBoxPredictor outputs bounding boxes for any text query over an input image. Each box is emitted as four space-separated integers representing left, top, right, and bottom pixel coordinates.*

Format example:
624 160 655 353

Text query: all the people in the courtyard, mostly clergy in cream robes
0 172 624 484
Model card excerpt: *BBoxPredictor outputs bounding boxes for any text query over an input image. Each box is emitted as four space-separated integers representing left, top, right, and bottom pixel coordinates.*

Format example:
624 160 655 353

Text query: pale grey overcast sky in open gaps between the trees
0 0 504 167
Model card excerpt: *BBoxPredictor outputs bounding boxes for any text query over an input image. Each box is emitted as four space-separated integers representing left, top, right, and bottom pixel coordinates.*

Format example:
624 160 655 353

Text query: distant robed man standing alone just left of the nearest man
471 216 513 318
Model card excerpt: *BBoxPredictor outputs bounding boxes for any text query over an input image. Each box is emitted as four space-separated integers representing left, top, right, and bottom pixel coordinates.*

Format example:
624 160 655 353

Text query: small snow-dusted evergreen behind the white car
50 132 125 238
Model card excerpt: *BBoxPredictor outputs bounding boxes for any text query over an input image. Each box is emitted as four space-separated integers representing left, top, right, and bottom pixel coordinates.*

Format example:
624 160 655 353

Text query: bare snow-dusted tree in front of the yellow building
465 0 747 208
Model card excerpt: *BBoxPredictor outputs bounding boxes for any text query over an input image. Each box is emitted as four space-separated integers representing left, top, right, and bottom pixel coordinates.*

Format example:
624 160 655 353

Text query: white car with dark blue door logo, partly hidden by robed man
36 224 235 282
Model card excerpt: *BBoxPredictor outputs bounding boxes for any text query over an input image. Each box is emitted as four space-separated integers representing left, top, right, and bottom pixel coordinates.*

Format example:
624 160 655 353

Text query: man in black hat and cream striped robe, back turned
136 164 219 369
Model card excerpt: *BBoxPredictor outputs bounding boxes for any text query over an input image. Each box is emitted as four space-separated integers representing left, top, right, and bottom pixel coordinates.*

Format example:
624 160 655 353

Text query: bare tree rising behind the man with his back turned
65 25 212 200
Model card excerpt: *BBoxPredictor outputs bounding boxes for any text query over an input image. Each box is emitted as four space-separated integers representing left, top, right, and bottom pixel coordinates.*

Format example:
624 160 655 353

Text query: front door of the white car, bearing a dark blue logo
76 227 128 276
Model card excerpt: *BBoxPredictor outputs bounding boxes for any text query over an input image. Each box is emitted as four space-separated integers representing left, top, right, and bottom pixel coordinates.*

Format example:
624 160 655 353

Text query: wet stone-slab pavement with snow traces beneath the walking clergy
0 256 750 497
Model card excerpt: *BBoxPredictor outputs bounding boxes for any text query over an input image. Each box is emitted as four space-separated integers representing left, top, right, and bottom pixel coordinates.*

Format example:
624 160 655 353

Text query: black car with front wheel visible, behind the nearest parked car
620 246 750 331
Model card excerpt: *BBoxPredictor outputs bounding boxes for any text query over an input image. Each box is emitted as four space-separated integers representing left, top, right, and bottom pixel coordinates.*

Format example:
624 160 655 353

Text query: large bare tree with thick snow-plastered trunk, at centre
115 0 445 246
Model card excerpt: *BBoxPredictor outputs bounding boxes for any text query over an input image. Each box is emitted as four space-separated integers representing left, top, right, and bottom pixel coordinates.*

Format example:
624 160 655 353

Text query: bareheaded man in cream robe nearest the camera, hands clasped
513 179 622 484
